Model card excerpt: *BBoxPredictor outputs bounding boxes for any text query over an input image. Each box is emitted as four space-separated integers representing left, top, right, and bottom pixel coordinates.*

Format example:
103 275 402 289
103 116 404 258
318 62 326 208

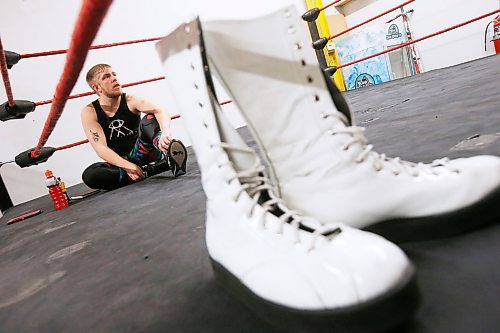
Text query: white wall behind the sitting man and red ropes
0 0 305 204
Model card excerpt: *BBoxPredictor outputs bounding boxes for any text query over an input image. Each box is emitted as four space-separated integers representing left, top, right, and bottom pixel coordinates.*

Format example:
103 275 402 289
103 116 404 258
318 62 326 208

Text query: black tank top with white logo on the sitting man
92 93 141 156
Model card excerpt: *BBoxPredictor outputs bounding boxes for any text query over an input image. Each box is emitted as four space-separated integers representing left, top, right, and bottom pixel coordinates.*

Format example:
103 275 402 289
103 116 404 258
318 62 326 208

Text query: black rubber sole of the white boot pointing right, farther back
363 187 500 243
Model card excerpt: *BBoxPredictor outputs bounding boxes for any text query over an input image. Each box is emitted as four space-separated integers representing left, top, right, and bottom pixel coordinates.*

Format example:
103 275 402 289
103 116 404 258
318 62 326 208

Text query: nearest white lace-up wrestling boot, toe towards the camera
157 20 418 332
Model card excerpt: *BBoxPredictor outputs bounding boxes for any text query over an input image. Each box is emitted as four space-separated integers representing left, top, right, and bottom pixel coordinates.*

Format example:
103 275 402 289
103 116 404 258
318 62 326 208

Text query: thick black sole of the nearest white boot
211 259 420 333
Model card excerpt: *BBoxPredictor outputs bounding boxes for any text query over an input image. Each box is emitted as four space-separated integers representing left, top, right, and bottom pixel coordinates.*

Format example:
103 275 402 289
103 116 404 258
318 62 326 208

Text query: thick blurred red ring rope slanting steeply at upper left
31 0 112 157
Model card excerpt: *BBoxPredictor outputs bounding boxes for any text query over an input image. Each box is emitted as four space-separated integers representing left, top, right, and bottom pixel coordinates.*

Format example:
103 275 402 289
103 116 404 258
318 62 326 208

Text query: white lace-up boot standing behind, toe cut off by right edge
203 7 500 242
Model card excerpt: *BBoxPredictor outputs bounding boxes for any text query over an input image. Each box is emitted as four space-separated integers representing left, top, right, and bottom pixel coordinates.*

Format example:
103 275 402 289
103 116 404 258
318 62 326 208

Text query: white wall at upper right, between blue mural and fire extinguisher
331 0 500 71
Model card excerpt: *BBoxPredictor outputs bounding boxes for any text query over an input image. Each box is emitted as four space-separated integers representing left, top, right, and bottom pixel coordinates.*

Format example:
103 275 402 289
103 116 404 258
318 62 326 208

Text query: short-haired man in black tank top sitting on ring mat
81 64 187 190
